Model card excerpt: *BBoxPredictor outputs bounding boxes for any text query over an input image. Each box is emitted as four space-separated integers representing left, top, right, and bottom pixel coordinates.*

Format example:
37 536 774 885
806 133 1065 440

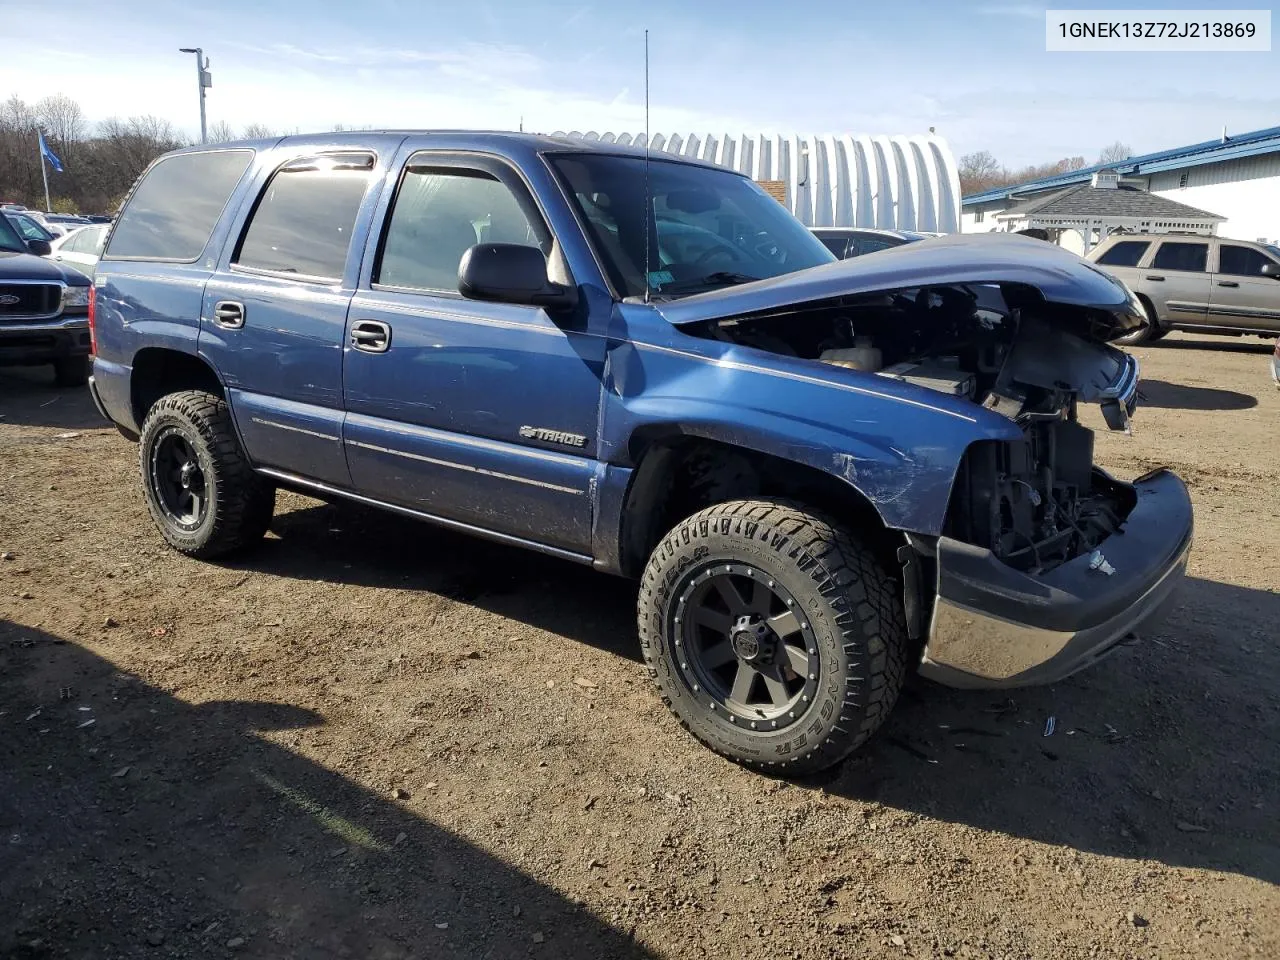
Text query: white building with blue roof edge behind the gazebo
961 127 1280 248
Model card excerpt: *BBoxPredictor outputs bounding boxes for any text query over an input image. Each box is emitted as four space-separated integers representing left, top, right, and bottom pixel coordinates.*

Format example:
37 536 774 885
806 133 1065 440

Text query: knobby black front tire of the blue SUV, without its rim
637 499 909 776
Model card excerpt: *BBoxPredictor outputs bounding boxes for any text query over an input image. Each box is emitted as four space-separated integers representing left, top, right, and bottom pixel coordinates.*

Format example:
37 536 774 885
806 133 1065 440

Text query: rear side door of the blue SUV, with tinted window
200 148 385 486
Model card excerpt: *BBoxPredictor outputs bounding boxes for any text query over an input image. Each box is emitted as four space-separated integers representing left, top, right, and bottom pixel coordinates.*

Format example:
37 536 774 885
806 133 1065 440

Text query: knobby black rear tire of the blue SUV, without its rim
138 390 275 559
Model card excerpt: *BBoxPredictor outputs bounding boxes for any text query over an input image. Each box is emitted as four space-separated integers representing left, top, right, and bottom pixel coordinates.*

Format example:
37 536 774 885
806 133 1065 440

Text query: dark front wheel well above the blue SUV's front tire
621 436 905 576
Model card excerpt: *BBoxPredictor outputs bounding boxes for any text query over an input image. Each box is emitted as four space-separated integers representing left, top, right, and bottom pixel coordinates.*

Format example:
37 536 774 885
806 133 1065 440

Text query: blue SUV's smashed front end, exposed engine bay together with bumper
670 243 1193 687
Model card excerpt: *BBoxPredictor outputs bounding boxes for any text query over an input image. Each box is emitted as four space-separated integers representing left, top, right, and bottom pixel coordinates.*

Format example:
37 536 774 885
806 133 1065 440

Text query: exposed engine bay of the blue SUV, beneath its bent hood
690 284 1138 573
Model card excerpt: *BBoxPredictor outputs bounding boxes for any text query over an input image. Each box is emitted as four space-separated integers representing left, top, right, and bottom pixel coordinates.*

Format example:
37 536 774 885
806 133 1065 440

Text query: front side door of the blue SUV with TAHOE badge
343 151 605 554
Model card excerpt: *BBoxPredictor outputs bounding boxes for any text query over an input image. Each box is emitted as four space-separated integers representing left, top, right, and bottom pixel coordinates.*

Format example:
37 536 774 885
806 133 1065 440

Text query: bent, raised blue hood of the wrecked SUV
657 233 1146 339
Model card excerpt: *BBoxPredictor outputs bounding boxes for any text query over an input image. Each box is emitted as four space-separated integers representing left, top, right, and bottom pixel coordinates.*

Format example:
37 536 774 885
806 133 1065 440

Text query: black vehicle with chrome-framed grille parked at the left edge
0 216 91 387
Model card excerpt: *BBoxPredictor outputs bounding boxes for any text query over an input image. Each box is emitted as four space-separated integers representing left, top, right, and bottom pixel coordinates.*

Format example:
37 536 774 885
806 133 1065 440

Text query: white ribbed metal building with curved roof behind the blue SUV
554 131 960 233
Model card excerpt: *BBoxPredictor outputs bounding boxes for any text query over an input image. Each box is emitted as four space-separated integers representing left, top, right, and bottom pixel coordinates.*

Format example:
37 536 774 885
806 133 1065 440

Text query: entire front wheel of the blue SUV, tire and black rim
637 500 908 774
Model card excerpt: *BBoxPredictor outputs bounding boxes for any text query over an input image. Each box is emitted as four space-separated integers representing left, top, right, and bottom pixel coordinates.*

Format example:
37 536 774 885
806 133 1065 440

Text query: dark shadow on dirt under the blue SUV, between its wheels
239 502 640 660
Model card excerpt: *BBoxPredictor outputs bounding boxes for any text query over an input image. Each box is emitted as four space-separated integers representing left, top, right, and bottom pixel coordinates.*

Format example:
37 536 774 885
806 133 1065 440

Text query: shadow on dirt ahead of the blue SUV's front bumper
814 577 1280 883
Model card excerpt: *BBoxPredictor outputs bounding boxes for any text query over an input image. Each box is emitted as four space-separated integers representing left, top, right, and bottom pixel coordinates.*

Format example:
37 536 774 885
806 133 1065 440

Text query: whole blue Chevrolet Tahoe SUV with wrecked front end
92 132 1192 773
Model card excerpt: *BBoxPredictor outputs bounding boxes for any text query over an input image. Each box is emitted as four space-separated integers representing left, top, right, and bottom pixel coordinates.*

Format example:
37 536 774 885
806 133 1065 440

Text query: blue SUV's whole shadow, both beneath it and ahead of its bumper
232 504 1280 883
